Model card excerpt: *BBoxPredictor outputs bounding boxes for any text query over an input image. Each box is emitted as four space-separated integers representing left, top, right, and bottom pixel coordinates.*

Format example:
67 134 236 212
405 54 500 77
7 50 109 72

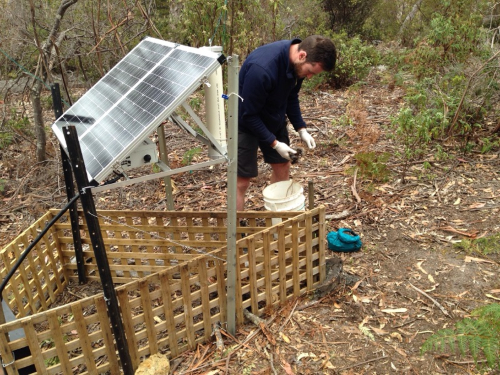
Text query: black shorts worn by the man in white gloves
238 126 290 178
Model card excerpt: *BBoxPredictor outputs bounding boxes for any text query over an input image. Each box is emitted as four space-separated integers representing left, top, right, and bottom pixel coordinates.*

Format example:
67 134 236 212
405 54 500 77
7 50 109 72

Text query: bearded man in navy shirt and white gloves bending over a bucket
236 35 336 211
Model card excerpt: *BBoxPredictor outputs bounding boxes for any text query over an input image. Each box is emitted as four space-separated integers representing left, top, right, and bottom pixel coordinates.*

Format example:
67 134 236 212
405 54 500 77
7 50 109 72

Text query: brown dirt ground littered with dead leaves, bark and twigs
0 68 500 374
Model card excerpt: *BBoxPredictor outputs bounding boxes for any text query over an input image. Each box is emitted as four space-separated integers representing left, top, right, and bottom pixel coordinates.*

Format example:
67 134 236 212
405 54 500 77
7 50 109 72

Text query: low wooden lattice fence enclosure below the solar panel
0 207 326 374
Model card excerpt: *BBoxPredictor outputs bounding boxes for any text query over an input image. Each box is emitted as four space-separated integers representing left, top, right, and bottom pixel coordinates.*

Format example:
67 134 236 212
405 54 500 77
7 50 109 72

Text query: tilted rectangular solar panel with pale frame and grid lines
52 38 224 183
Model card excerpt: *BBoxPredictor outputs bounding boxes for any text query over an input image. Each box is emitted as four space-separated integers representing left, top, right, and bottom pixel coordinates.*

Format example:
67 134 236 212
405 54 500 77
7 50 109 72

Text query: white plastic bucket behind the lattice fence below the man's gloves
262 180 305 225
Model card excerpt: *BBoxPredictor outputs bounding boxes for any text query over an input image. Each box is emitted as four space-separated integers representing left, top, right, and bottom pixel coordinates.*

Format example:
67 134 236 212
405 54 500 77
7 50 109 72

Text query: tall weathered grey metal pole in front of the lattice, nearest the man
227 55 239 335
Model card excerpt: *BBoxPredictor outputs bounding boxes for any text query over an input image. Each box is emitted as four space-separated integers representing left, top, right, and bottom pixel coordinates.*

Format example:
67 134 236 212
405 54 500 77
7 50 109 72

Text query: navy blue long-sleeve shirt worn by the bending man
238 39 306 144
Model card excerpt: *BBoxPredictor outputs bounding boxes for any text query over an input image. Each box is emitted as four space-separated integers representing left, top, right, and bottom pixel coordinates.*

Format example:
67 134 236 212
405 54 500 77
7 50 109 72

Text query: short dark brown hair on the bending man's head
299 35 337 72
